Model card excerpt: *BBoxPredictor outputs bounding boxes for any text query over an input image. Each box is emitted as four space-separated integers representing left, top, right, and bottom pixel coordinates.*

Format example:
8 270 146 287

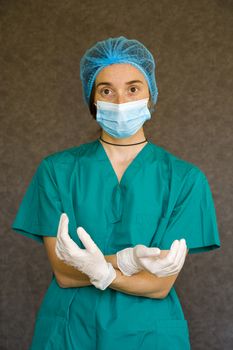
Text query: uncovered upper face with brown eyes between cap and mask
94 63 150 106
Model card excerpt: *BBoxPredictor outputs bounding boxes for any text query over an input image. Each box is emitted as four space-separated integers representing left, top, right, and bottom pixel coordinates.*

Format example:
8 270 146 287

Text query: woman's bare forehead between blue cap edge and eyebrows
96 63 146 84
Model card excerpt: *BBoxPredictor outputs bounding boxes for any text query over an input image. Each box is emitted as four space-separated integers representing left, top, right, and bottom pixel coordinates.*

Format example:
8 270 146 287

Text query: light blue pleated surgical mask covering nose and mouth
96 98 151 138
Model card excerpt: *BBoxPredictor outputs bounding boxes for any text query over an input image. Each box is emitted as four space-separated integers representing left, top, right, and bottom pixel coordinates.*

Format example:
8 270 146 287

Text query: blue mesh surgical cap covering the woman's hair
80 36 158 108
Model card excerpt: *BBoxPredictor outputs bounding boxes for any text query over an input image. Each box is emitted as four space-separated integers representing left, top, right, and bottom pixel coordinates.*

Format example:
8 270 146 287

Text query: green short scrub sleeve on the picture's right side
159 171 220 254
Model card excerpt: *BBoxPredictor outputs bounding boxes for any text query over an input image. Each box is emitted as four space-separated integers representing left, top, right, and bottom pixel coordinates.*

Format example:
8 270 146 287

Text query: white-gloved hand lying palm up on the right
116 239 187 277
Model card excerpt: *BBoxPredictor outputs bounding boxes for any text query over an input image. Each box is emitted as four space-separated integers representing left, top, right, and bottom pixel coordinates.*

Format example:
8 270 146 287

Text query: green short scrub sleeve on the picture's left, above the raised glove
11 157 62 243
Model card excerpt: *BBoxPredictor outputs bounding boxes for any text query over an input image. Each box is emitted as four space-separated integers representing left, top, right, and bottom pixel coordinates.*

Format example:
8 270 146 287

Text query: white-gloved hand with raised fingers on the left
55 213 116 290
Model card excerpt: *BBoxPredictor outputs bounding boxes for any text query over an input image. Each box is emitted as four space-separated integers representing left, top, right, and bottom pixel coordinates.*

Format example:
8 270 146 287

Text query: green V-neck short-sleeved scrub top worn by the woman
12 139 220 350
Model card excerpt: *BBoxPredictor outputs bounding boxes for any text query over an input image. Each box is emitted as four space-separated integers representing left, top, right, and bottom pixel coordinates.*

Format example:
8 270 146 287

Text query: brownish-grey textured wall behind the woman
0 0 233 350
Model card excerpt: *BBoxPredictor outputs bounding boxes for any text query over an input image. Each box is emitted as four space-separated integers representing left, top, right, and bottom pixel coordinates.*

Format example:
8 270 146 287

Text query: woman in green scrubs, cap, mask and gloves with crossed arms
12 36 220 350
